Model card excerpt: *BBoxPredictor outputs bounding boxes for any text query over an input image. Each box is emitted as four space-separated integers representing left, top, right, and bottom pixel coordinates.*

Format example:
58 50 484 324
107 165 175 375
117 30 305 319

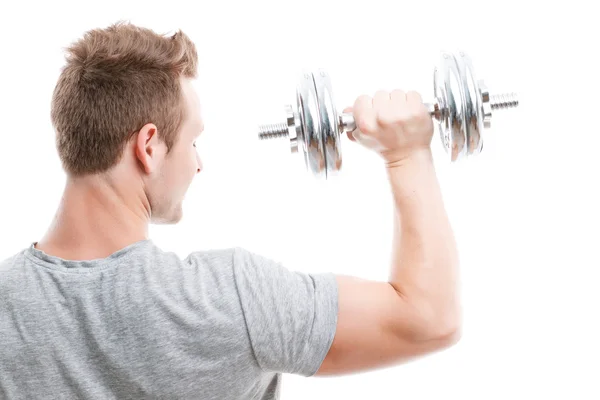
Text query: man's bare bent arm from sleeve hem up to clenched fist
317 92 460 376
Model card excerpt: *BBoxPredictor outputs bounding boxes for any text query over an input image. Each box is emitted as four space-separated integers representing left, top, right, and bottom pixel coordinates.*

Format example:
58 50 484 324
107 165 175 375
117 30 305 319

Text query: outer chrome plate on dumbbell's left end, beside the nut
296 71 325 176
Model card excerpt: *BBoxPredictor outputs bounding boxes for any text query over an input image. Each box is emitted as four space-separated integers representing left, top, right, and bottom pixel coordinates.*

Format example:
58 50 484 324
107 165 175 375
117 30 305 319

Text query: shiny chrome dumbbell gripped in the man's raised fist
258 51 519 178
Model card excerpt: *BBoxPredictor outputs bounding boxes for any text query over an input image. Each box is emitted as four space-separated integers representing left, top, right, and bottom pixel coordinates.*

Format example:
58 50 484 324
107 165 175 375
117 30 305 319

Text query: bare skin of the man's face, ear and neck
36 79 204 260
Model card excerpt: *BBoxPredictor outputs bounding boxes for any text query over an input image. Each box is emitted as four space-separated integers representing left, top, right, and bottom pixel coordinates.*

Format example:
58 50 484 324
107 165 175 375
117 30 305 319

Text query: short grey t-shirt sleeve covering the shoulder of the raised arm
234 248 338 377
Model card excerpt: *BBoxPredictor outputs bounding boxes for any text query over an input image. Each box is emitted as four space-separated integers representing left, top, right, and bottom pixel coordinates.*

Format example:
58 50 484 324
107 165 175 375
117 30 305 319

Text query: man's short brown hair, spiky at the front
50 21 198 176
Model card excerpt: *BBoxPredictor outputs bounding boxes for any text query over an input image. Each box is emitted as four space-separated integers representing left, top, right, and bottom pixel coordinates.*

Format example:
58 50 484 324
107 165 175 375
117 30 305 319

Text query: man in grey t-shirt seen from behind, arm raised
0 23 461 399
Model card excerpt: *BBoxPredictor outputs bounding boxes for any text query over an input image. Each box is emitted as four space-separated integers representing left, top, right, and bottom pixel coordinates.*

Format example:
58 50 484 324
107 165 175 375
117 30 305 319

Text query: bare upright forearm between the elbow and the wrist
386 151 460 335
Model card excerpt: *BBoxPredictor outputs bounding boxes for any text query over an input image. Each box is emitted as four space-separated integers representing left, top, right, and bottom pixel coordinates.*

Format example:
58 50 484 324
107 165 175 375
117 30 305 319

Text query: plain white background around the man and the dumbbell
0 0 600 400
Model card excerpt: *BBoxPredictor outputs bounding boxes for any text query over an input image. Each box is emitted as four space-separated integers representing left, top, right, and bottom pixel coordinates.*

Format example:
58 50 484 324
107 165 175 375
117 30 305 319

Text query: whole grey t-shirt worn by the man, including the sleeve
0 239 338 400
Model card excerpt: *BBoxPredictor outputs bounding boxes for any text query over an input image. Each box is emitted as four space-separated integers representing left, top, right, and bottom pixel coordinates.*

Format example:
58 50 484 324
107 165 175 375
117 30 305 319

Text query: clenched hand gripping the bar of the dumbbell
344 90 433 165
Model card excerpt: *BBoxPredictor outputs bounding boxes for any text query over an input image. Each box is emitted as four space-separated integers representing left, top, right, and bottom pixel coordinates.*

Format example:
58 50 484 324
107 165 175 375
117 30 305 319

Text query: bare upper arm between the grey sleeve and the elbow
316 276 452 376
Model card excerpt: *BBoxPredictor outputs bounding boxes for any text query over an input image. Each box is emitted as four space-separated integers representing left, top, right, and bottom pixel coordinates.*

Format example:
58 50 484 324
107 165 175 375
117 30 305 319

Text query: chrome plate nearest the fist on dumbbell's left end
313 69 342 177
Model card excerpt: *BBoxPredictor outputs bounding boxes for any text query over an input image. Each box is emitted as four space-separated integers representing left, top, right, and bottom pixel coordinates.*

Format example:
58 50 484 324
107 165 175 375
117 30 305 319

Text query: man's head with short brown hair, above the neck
51 23 203 223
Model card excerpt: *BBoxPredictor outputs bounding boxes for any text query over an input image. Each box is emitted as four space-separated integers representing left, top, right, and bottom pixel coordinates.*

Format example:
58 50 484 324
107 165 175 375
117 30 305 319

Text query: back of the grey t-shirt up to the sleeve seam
0 240 268 399
